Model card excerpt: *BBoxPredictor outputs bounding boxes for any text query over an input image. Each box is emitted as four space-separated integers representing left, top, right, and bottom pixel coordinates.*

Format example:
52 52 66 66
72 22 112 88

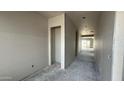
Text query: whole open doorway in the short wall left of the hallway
51 26 61 65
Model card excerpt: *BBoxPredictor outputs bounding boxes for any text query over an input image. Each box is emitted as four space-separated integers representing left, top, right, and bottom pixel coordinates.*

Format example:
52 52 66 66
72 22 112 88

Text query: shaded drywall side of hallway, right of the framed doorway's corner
65 15 76 67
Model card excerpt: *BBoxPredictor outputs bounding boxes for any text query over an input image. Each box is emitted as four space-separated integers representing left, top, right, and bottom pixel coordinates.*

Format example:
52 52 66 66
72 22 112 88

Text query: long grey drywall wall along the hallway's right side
96 12 115 80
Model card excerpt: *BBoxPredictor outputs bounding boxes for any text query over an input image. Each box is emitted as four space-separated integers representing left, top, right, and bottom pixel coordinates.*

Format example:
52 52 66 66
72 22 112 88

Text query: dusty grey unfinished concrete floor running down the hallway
25 51 99 81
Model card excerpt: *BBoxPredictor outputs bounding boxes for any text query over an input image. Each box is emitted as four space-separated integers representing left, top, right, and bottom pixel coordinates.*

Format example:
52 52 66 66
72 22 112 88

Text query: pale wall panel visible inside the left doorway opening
55 28 61 63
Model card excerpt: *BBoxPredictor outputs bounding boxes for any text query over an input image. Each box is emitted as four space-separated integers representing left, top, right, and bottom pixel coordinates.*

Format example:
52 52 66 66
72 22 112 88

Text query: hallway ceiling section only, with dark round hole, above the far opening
67 11 100 35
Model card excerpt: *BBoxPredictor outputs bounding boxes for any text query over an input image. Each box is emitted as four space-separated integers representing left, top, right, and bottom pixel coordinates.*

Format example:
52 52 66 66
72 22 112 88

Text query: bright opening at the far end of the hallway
79 35 95 62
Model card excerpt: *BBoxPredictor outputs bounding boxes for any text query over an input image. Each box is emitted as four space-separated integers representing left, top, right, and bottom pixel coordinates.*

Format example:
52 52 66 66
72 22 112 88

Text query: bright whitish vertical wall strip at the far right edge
112 12 124 80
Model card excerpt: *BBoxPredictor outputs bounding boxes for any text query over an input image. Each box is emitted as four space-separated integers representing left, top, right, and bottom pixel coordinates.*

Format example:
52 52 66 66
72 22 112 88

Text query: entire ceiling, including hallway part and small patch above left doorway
39 11 100 35
